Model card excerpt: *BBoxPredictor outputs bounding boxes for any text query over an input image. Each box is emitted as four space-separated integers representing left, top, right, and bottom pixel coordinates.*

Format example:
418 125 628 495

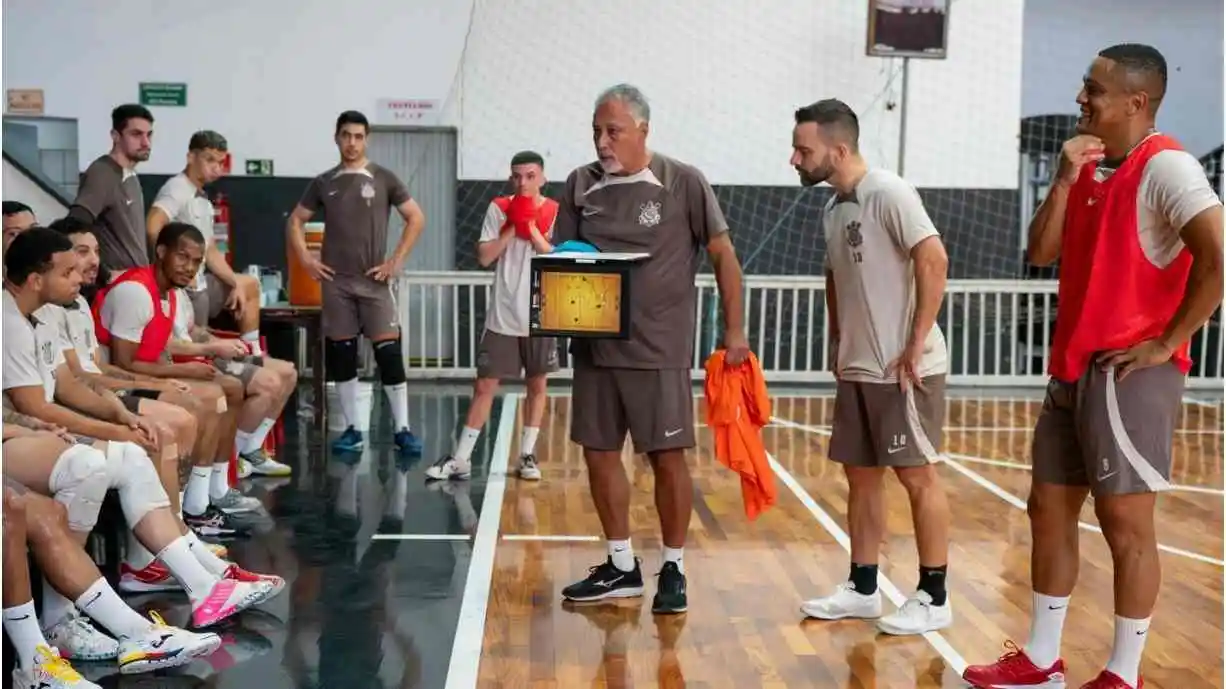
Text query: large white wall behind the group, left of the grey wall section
4 0 1022 188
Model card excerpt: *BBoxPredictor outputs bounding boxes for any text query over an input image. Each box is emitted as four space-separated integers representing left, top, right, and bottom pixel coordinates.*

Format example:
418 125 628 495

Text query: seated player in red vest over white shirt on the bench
94 222 298 483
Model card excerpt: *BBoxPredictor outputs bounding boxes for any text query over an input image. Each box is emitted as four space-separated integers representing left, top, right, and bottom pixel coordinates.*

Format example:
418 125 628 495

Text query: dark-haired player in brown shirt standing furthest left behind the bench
69 103 153 276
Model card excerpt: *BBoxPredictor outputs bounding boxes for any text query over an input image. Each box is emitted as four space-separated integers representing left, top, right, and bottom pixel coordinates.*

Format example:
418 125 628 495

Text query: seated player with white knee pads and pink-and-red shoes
2 228 284 626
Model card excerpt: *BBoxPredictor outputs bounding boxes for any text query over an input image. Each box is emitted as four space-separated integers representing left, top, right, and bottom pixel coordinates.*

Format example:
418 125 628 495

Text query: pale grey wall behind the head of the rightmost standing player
1021 0 1222 156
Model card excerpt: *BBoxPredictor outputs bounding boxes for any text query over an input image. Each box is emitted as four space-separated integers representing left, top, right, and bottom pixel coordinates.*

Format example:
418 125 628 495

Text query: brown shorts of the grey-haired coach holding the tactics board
570 362 695 454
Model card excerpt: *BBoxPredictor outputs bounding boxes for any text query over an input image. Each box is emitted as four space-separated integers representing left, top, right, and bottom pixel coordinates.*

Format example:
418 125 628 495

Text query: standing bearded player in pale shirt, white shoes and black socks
792 98 953 635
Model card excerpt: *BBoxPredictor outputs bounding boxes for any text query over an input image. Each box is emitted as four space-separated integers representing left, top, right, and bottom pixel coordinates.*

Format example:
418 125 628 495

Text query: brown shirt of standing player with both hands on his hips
298 163 412 276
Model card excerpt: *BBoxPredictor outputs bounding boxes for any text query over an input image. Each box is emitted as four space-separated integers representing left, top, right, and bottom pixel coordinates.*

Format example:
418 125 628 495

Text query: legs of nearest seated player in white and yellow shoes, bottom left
4 458 222 676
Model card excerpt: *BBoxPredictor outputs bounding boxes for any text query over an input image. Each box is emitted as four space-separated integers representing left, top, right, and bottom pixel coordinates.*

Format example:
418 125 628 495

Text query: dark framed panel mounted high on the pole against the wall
868 0 949 60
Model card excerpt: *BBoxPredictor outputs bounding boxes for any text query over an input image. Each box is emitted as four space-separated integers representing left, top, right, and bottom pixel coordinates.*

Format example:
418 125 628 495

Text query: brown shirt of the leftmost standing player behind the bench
69 156 150 272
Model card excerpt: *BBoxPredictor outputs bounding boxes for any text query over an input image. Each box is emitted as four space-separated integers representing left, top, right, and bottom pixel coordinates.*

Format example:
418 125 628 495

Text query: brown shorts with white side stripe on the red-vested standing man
1031 363 1184 495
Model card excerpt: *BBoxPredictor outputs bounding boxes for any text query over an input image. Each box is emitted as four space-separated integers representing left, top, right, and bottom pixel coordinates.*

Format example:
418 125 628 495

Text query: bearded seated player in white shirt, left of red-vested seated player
48 217 261 514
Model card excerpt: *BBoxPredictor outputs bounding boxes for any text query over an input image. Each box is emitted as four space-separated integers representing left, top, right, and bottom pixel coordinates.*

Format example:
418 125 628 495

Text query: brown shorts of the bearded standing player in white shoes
829 375 945 467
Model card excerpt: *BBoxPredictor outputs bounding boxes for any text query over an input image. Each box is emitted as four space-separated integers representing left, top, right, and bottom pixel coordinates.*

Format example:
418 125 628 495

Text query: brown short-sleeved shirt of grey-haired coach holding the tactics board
553 153 728 369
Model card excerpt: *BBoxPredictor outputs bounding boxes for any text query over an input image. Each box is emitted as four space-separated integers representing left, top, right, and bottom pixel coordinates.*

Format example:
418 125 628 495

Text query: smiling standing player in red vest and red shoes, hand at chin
962 44 1222 689
